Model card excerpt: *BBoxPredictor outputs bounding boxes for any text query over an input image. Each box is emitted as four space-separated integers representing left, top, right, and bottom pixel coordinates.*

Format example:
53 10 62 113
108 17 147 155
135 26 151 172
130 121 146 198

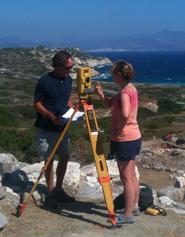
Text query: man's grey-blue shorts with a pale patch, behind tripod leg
36 128 70 161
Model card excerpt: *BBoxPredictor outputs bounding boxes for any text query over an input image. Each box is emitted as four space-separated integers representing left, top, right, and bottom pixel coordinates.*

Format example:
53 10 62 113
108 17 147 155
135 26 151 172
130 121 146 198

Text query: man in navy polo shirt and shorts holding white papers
34 50 74 201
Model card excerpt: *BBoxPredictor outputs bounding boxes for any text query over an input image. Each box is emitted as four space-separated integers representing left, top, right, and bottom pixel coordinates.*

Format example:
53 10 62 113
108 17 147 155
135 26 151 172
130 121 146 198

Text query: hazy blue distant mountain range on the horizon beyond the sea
0 30 185 51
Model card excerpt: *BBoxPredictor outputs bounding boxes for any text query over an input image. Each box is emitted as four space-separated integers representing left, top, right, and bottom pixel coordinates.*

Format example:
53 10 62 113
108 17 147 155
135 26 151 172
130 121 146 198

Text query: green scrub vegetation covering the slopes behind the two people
0 46 185 163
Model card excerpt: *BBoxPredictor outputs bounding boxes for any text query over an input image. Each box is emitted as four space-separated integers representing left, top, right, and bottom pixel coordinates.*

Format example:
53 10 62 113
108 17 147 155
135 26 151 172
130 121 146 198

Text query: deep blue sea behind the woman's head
88 52 185 85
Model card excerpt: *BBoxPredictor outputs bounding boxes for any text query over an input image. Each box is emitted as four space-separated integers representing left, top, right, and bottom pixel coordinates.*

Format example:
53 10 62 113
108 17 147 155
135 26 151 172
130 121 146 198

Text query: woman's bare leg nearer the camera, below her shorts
118 160 138 216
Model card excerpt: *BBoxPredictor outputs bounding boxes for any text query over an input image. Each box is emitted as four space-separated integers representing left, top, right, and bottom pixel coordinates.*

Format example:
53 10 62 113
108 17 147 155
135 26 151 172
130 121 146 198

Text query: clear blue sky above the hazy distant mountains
0 0 185 41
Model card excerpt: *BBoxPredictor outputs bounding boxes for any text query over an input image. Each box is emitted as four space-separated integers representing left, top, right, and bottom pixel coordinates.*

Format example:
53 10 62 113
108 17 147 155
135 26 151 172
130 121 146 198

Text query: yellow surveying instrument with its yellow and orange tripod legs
17 67 116 227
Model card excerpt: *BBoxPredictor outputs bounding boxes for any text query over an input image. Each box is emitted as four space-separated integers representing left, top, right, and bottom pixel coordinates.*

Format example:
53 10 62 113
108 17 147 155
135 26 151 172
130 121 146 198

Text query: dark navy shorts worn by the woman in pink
109 138 142 161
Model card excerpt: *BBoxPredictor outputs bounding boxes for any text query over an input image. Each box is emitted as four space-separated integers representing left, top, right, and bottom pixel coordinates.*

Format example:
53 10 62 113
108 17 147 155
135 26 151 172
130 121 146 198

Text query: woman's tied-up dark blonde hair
111 60 135 80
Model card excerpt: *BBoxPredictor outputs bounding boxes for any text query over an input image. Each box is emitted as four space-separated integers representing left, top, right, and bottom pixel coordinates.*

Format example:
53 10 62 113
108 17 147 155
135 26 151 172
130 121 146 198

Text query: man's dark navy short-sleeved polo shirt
34 72 72 132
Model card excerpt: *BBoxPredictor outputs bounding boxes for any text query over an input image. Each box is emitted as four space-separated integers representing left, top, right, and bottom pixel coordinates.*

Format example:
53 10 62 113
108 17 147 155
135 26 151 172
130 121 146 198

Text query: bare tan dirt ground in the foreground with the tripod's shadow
0 198 185 237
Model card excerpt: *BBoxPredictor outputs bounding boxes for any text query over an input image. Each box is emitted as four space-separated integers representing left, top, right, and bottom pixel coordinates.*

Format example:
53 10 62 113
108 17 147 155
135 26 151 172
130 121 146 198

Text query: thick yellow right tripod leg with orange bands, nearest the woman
83 105 116 226
